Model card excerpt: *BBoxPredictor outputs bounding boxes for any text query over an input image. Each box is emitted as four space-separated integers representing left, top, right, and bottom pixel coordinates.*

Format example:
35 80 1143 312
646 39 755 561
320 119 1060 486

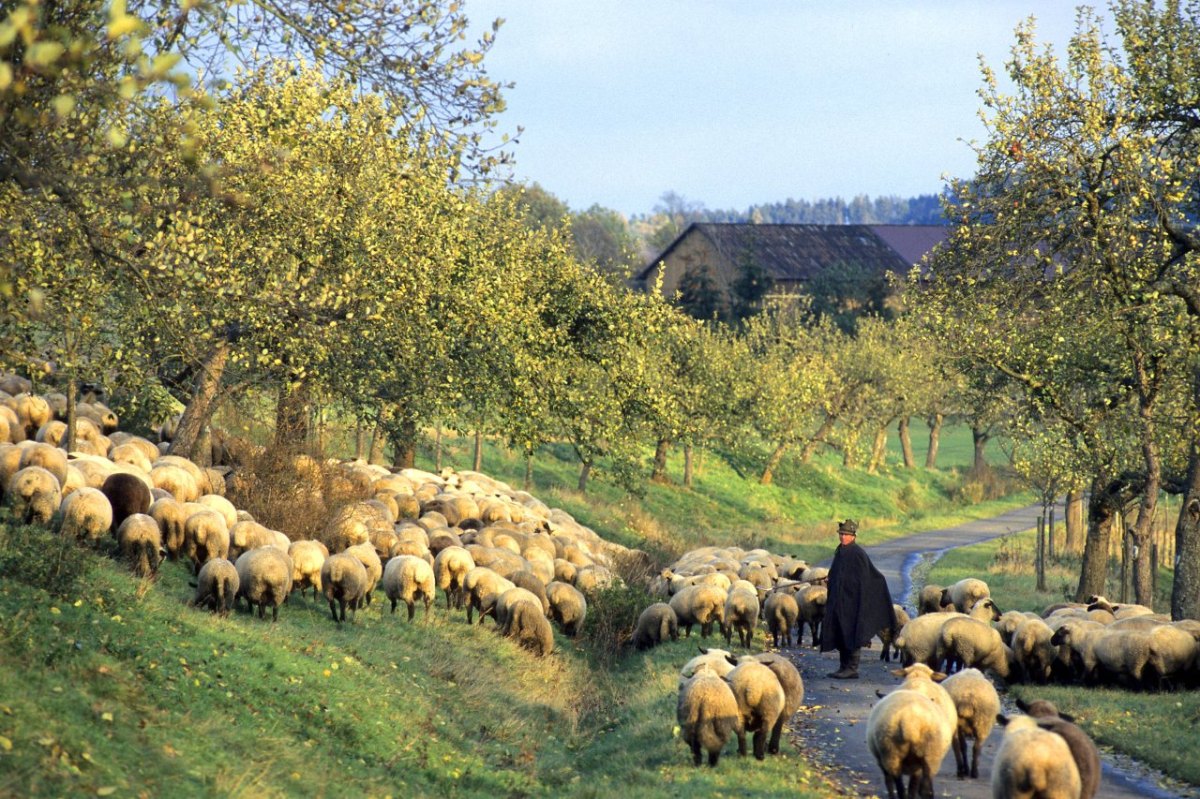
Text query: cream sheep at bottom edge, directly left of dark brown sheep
991 716 1081 799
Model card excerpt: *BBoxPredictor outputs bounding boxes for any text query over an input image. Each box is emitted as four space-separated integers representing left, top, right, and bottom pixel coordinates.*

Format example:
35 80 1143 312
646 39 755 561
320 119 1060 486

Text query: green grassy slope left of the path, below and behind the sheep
0 419 1032 797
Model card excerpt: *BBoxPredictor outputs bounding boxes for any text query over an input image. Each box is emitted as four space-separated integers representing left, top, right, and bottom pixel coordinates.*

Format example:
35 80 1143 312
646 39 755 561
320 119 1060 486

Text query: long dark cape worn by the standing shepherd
821 543 895 651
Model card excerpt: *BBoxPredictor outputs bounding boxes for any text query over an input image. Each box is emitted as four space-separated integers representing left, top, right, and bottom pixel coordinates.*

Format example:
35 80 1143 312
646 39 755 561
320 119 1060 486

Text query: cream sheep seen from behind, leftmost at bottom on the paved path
866 686 954 799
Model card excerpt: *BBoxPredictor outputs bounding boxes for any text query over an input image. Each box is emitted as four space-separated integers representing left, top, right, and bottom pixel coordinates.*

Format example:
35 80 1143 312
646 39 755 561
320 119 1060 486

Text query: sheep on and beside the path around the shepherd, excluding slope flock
634 547 1200 799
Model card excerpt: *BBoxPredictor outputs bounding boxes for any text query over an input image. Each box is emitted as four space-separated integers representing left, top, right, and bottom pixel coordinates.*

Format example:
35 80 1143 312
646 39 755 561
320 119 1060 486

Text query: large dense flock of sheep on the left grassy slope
0 376 628 655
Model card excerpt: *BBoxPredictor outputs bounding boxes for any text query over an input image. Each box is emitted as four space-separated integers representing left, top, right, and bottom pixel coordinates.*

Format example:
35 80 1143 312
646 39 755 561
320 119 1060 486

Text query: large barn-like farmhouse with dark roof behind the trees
634 223 947 306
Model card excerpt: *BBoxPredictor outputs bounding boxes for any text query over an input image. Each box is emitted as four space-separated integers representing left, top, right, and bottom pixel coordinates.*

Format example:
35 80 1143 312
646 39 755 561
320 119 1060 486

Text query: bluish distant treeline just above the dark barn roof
697 189 946 224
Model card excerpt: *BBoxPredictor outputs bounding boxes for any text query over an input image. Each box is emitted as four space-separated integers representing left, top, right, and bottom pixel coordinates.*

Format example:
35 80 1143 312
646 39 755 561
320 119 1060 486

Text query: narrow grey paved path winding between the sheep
786 507 1200 799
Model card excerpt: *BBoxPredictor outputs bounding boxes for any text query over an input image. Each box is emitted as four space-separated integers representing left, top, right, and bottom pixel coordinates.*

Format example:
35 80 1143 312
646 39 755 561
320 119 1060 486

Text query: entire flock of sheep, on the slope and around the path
0 376 1200 799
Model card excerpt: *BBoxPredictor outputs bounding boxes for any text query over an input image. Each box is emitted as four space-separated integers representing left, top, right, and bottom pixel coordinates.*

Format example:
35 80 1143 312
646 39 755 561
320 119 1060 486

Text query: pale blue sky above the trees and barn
463 0 1111 215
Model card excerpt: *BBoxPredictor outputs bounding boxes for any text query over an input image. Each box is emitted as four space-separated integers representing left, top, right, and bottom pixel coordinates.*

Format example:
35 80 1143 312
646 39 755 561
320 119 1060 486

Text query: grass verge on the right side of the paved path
928 530 1200 786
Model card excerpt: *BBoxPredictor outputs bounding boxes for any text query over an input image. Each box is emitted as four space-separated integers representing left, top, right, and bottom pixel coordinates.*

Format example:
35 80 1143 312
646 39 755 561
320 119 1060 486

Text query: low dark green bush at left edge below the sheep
0 510 95 597
